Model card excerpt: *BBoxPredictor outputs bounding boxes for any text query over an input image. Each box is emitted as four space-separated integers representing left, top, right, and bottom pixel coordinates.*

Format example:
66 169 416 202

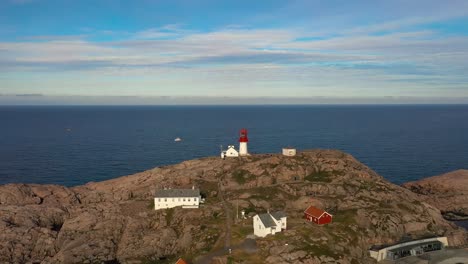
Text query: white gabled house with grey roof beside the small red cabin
253 211 286 237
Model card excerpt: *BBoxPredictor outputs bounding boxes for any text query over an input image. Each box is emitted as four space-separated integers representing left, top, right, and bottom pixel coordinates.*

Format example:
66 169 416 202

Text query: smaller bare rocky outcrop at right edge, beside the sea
403 170 468 220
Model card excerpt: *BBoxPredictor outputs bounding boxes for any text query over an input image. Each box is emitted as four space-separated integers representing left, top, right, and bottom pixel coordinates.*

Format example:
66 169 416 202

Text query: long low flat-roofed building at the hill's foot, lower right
369 237 448 261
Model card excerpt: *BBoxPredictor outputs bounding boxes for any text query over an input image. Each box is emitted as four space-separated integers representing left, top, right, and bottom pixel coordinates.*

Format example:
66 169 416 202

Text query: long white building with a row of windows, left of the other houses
154 188 201 210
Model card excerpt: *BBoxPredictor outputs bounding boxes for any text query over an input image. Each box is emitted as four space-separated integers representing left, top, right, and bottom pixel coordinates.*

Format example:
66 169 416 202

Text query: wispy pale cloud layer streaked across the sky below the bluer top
0 1 468 101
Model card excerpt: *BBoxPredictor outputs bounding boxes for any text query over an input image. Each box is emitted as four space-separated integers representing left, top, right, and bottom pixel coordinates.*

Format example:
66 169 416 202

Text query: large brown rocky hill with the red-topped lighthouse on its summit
0 150 467 263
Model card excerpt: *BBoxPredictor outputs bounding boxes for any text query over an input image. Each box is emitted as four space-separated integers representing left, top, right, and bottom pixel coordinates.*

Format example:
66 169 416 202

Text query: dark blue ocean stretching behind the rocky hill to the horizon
0 105 468 186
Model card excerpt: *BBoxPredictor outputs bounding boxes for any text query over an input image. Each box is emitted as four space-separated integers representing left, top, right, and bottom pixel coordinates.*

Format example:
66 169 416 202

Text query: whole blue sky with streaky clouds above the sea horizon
0 0 468 104
